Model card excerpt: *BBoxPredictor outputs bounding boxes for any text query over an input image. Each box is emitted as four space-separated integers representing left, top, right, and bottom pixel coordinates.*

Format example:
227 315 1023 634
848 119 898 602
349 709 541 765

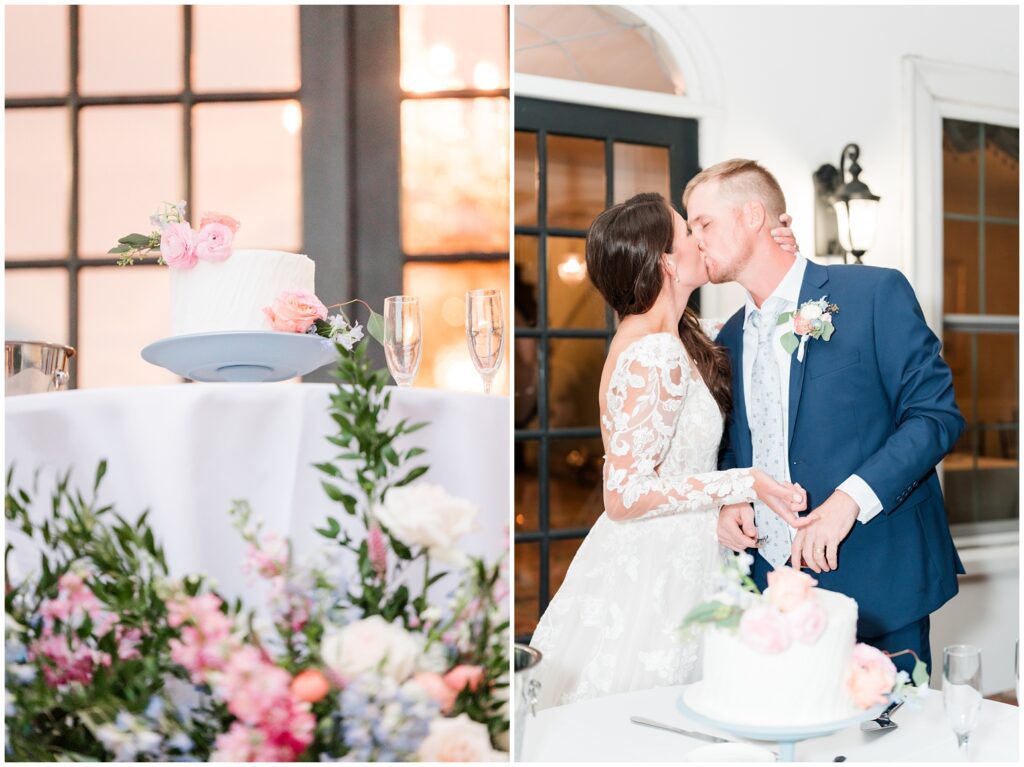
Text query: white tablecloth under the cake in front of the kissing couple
523 686 1020 763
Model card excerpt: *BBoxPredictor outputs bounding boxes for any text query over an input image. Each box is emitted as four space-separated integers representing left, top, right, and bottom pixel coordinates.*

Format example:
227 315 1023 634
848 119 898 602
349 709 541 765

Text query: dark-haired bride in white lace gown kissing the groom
531 194 806 708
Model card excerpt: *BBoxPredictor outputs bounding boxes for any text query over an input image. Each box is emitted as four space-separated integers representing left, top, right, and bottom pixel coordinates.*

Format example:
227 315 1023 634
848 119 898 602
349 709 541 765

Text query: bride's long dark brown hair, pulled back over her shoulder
587 193 732 416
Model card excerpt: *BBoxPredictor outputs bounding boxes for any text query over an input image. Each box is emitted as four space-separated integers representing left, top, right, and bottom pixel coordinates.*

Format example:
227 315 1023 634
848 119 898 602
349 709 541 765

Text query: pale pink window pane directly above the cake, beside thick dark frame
189 101 301 250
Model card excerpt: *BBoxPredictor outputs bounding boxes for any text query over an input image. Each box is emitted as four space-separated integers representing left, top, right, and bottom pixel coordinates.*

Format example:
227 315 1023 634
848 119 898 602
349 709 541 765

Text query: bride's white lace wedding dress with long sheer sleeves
531 333 754 708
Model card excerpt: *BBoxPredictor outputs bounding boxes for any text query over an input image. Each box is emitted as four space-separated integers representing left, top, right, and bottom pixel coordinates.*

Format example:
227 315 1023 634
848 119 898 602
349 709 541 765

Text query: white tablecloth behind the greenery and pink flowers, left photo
5 384 510 596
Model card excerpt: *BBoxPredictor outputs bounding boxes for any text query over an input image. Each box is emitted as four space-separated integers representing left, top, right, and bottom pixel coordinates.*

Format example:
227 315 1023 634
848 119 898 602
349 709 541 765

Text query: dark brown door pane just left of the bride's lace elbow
548 437 604 529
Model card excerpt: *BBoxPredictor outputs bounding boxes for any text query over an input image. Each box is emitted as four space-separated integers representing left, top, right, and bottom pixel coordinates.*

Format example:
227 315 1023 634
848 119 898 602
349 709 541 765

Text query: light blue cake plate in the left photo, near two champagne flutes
142 331 338 383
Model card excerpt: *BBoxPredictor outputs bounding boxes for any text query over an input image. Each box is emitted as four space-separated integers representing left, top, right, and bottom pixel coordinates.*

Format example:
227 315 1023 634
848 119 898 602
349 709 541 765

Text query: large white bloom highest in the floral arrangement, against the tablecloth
374 484 479 567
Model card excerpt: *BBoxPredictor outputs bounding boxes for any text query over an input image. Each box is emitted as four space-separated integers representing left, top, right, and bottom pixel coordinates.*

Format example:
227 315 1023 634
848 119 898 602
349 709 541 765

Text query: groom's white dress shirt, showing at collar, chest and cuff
743 254 882 540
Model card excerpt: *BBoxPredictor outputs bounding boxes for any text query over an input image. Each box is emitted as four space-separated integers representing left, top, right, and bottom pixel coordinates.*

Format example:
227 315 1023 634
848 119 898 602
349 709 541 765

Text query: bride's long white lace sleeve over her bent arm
601 337 755 522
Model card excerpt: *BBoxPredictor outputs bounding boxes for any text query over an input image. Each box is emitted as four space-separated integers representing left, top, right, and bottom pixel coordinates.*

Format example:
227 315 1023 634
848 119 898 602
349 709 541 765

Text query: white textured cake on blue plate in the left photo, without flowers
171 250 315 336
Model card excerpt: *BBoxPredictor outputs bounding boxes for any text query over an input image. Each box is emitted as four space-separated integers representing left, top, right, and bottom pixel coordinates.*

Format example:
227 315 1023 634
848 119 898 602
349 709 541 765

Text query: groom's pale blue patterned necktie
748 296 792 567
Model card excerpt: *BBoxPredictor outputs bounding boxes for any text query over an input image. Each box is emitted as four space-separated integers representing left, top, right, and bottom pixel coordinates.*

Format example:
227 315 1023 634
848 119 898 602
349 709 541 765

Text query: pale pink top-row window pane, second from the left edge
79 5 184 95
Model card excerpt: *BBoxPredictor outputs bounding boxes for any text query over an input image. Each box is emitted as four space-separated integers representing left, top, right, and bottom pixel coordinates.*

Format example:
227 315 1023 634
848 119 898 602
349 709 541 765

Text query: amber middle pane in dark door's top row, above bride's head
547 136 604 229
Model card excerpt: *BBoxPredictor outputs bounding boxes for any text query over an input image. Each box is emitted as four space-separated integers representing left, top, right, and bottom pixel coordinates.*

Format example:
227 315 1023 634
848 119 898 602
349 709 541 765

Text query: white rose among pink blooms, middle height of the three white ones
321 615 423 682
